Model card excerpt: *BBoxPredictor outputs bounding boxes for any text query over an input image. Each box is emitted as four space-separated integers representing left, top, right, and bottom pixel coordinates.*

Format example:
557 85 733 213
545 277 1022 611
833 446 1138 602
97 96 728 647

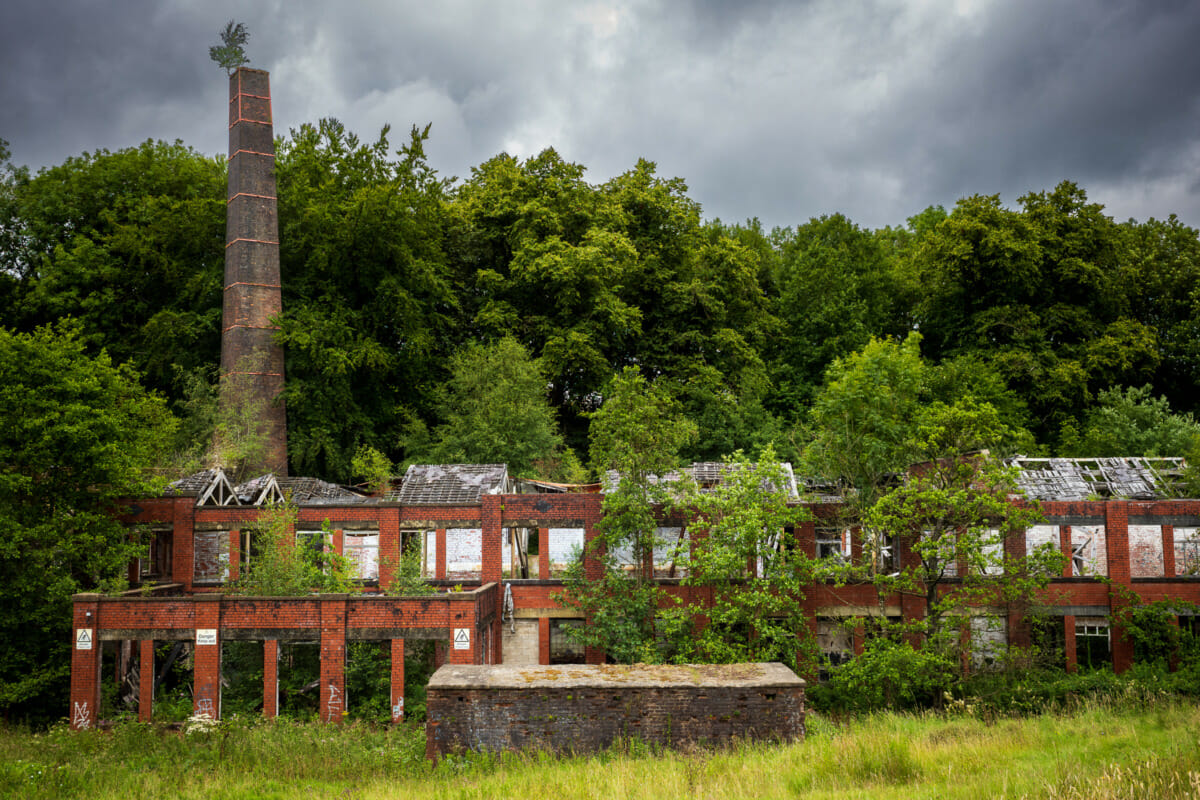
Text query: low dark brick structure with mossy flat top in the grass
425 663 804 760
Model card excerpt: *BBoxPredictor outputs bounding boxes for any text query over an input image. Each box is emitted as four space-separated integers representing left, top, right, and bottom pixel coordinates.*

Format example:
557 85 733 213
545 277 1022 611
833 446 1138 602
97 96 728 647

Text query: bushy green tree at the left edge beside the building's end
0 323 175 721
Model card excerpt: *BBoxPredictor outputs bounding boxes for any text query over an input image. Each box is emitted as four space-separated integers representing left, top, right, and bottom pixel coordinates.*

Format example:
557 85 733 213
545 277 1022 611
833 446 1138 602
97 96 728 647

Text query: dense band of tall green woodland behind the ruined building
7 126 1200 489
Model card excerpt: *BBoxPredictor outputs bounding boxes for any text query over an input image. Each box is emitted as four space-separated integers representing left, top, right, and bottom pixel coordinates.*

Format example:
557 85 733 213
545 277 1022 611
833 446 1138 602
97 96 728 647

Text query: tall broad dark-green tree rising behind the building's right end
911 181 1162 444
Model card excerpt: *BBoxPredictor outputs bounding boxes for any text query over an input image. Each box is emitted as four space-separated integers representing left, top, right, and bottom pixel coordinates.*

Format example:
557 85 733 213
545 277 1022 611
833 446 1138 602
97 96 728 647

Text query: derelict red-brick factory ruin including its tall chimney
60 68 1200 728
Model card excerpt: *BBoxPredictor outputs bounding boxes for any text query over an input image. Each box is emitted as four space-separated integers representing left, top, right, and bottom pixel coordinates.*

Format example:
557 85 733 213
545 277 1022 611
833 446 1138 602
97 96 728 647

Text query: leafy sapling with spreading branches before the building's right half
862 398 1062 663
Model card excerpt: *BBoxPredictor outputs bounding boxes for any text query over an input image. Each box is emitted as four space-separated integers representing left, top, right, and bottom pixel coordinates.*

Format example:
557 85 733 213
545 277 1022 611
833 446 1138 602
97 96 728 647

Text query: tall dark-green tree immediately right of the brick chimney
277 120 457 480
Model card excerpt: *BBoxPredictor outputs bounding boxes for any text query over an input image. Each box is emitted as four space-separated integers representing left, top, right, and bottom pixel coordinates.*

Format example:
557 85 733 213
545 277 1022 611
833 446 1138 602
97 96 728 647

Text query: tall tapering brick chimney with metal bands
218 67 288 475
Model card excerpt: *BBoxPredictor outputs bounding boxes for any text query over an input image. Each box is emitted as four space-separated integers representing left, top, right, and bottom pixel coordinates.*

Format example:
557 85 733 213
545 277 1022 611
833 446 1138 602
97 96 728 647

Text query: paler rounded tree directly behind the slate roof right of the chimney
409 337 581 477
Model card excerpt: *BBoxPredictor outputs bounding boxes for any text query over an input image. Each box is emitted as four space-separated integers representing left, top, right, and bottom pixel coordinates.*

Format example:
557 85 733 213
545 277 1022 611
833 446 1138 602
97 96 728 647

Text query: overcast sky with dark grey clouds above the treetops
0 0 1200 227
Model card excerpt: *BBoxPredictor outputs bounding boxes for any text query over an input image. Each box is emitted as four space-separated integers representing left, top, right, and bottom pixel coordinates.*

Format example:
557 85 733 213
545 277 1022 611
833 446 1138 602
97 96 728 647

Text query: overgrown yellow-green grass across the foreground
0 696 1200 800
